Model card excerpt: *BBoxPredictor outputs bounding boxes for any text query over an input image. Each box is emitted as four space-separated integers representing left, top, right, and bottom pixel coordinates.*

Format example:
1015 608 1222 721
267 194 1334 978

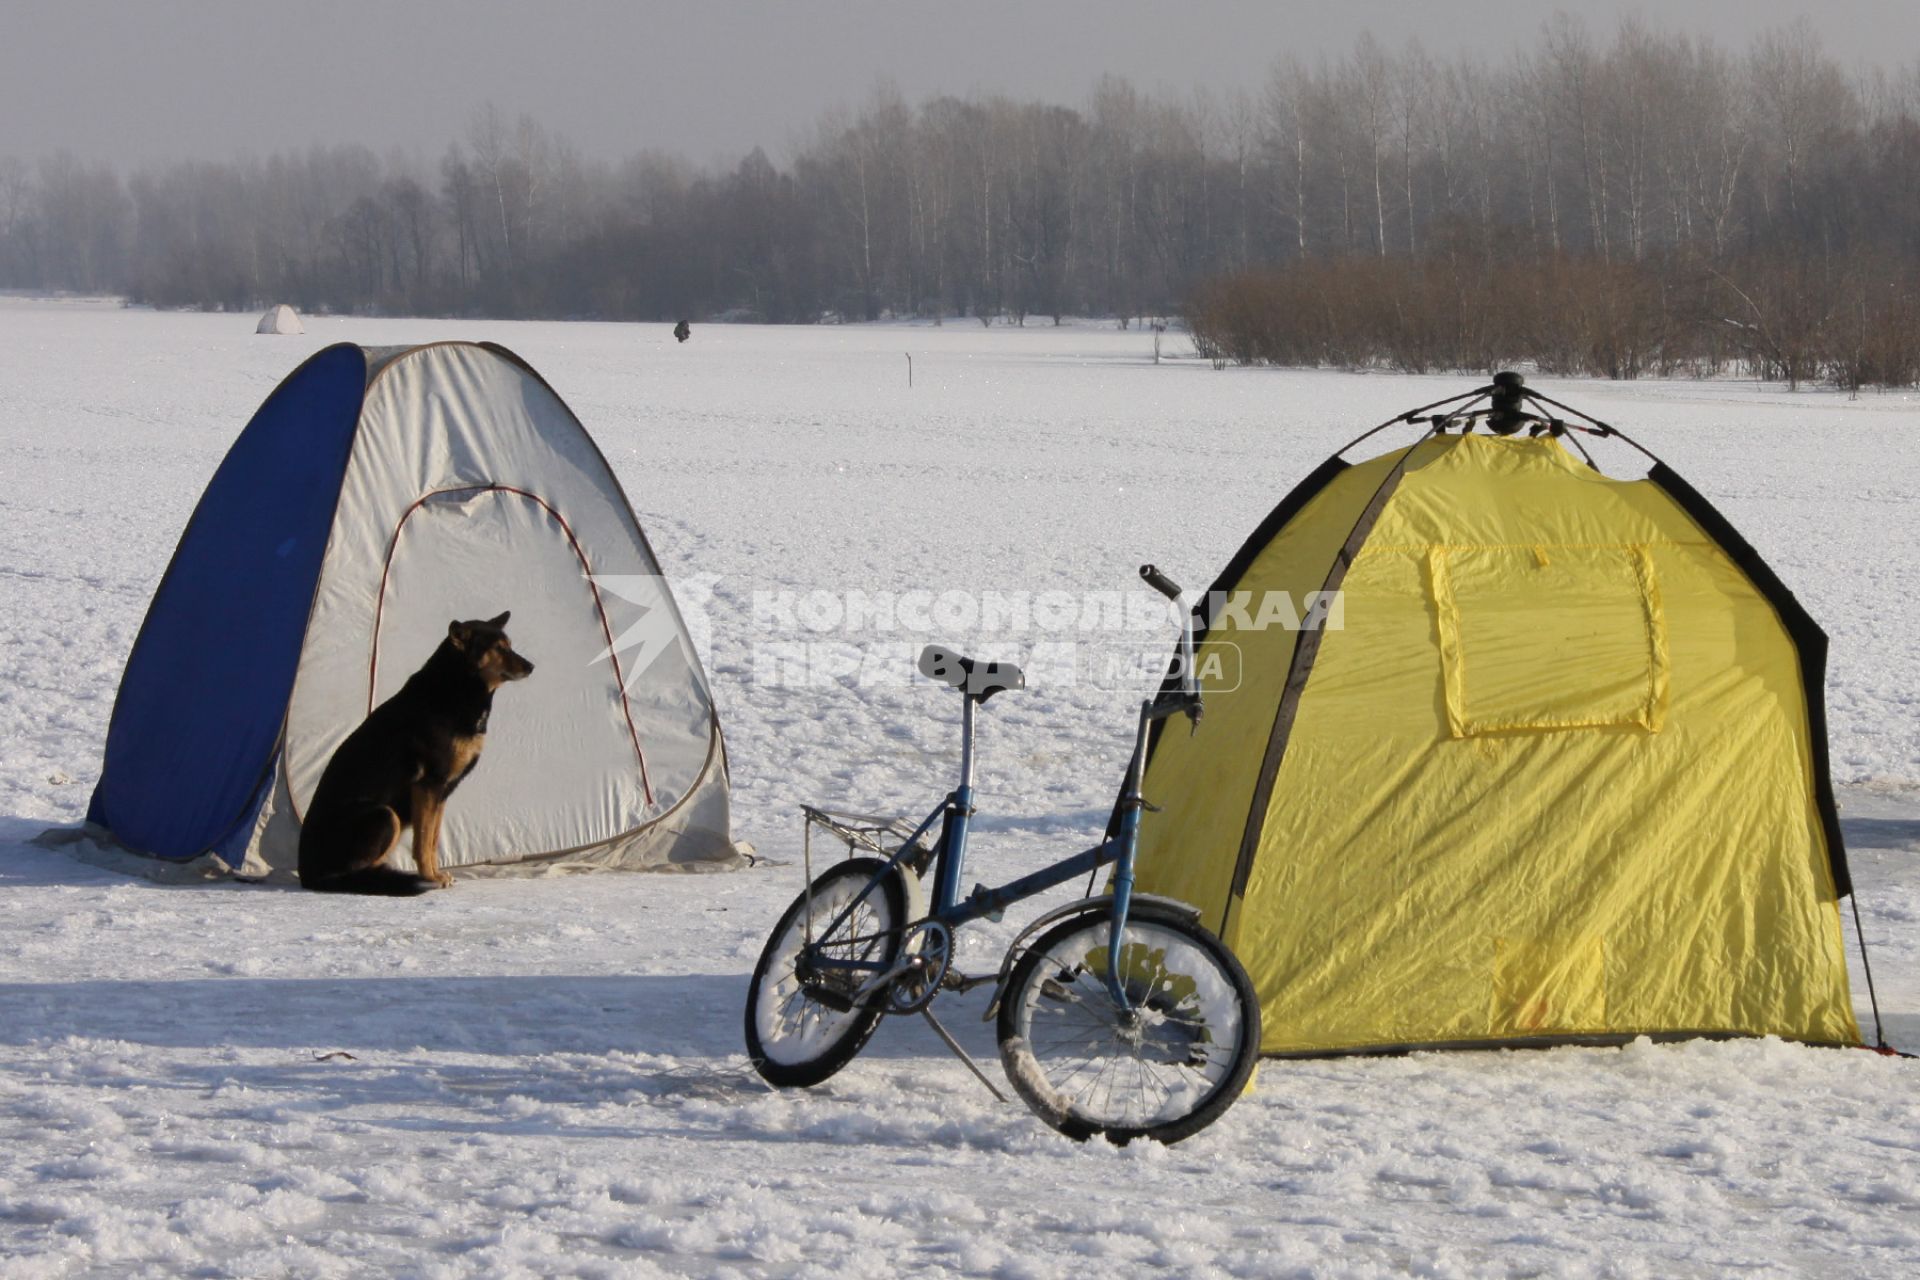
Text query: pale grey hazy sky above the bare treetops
0 0 1920 165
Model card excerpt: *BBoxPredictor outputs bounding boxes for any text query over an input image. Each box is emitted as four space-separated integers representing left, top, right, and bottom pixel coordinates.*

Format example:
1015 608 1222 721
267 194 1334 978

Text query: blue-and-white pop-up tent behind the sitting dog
88 342 737 875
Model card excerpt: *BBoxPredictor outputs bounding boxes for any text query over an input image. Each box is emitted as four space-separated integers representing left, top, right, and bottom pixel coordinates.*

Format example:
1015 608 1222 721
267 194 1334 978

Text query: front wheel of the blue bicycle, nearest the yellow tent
998 910 1260 1144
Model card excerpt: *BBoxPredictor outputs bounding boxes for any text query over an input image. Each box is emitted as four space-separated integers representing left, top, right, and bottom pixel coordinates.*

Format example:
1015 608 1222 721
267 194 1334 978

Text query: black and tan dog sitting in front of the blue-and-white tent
300 614 534 898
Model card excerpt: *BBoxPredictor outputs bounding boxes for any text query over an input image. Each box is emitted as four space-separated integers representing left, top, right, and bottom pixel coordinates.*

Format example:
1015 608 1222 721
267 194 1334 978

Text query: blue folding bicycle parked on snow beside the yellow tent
747 564 1260 1144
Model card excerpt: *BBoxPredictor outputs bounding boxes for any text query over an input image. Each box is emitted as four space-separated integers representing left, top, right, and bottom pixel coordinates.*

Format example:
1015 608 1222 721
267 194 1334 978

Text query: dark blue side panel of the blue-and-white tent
86 344 367 865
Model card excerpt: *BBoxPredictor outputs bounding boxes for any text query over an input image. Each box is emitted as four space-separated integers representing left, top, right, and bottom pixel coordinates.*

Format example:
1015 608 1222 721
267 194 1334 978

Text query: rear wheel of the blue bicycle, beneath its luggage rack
747 858 906 1088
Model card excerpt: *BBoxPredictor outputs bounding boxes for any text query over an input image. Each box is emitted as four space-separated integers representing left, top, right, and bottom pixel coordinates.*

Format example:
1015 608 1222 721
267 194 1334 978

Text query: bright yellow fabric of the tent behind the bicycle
1137 436 1860 1054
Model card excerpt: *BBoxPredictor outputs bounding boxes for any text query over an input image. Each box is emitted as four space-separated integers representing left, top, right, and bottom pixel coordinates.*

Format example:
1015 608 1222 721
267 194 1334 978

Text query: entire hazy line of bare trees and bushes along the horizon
0 17 1920 382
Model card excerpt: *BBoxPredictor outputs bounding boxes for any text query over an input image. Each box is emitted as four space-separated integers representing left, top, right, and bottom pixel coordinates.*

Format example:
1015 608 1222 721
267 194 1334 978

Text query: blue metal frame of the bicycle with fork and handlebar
808 564 1202 1017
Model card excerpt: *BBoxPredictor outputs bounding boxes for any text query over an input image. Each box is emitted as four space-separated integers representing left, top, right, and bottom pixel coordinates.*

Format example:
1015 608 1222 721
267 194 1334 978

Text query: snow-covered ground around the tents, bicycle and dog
0 299 1920 1278
